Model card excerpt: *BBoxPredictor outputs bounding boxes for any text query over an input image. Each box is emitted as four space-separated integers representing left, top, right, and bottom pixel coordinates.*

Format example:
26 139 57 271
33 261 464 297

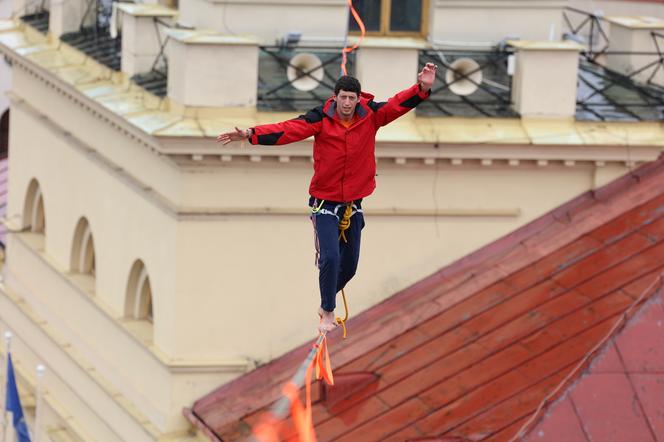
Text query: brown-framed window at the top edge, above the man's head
348 0 429 37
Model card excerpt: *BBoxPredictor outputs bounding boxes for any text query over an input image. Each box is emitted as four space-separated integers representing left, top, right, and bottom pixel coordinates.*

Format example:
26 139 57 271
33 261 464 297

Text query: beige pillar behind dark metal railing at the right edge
606 17 664 86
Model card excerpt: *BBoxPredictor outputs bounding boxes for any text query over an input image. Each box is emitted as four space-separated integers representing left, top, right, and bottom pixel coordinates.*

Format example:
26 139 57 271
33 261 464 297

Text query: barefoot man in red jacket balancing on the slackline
217 63 437 331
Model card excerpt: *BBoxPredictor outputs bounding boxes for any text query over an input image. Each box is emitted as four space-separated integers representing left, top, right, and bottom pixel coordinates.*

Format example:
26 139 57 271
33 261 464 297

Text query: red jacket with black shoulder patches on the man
249 84 431 202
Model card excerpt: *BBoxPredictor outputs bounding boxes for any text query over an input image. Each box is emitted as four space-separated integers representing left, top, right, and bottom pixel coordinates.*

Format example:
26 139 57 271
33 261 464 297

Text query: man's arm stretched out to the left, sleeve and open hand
217 106 323 146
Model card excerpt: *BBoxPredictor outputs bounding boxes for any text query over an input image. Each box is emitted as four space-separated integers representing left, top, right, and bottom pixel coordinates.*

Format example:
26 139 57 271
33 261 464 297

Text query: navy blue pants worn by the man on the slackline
309 197 364 312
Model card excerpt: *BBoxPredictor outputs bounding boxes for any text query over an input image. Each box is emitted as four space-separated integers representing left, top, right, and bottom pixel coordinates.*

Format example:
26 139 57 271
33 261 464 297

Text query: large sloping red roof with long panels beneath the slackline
188 155 664 441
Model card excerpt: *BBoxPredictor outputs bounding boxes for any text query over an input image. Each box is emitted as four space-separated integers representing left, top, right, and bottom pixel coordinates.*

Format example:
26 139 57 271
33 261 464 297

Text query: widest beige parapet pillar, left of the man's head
168 29 259 107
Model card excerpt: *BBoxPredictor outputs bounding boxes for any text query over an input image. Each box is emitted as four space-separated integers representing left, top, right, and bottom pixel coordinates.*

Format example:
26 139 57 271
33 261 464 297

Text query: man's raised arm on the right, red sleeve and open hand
369 63 437 126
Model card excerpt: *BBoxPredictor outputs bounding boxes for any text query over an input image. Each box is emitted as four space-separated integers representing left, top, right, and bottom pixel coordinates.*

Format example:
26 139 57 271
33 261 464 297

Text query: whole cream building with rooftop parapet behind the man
0 0 664 441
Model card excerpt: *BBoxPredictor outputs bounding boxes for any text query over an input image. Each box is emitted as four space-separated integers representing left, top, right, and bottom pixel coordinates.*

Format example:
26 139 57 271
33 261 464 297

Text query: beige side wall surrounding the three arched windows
5 73 245 440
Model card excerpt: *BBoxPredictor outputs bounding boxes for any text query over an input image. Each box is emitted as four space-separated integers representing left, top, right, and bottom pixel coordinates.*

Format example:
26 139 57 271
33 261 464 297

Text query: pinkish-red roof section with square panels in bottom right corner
527 292 664 442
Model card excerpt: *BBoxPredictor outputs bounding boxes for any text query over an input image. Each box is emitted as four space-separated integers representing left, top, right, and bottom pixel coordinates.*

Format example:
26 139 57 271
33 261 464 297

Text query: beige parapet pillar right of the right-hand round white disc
509 40 583 117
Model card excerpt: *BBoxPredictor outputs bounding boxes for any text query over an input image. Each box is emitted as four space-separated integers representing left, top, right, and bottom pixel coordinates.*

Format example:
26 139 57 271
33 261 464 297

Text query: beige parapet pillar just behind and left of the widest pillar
117 3 177 76
